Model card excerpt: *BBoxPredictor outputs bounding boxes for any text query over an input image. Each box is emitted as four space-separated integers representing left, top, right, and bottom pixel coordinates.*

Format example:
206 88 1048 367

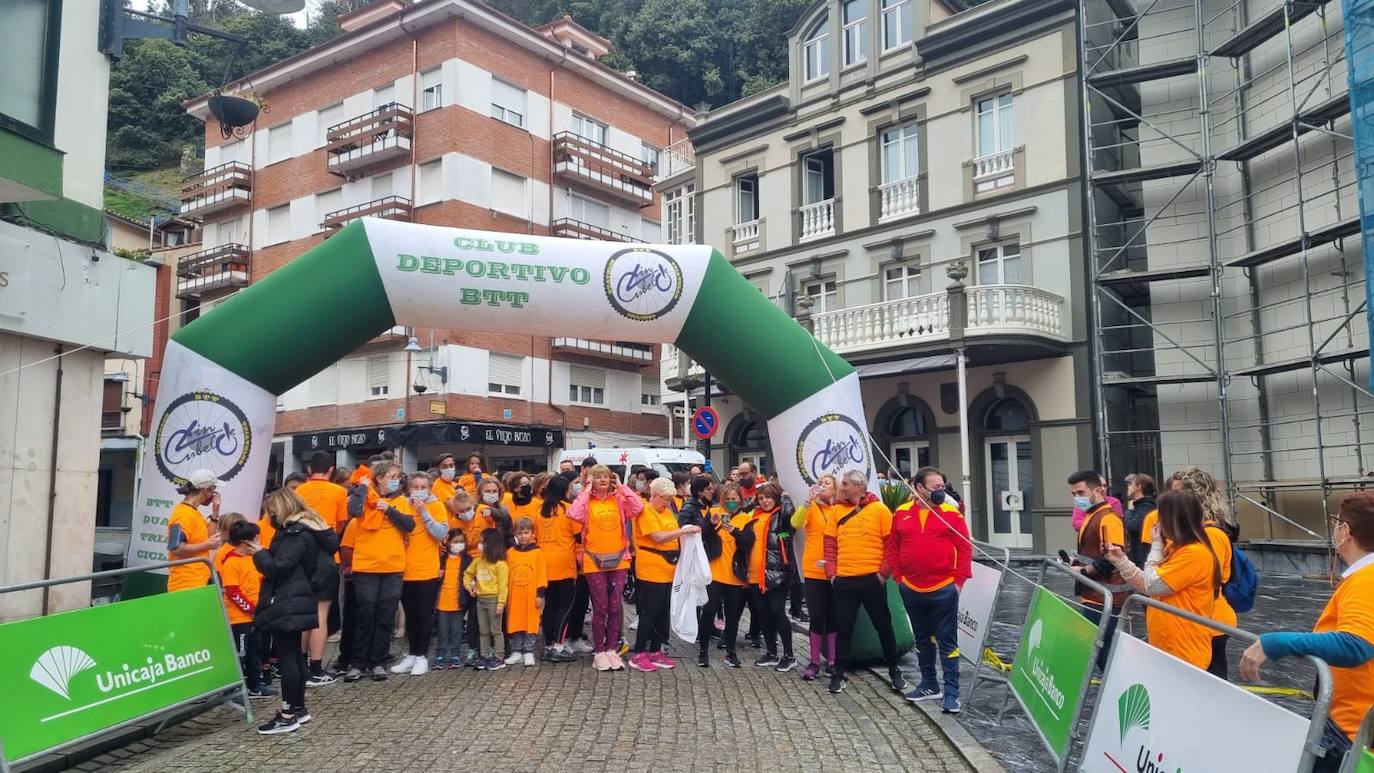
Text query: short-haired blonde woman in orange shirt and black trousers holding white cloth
629 478 701 673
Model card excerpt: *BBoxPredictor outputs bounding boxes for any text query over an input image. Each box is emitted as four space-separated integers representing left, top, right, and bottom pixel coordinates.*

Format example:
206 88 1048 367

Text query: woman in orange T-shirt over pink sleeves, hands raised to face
567 464 644 671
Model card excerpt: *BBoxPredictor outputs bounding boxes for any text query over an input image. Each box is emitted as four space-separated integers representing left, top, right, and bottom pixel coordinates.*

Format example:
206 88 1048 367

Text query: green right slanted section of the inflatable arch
676 250 853 419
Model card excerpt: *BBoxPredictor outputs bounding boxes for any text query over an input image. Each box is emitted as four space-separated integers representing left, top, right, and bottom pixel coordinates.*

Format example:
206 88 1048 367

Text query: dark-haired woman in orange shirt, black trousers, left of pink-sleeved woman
534 475 577 663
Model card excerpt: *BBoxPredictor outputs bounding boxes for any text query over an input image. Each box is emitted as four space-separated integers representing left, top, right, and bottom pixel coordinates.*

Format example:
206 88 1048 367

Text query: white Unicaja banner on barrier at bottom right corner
1081 634 1311 773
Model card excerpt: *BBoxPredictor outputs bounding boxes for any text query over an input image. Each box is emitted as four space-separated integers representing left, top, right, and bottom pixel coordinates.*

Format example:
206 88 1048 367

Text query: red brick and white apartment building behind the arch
179 0 695 476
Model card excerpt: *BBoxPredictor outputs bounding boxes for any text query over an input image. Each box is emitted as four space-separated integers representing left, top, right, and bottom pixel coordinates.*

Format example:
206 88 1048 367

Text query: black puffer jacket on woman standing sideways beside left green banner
253 522 331 632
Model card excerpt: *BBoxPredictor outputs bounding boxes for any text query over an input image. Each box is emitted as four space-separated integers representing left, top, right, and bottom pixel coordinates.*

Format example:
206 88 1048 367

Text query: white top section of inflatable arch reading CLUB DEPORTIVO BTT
364 220 710 343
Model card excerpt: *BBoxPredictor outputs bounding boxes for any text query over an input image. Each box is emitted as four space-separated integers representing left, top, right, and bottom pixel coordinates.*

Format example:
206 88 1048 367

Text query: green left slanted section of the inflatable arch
172 221 396 394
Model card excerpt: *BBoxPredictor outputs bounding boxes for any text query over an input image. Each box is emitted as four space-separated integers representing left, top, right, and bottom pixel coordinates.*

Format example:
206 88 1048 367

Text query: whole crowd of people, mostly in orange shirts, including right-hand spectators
168 453 1374 768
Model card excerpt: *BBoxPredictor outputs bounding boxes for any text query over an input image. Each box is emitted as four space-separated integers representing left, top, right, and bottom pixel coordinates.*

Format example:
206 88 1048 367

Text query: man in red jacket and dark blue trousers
886 467 973 714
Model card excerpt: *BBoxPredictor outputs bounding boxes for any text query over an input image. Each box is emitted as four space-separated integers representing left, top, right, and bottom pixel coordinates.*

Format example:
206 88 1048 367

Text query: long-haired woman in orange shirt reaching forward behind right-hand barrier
1106 492 1221 670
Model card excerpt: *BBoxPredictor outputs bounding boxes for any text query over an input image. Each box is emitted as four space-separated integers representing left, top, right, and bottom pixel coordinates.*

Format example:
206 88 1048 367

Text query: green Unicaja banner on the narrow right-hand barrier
1011 588 1098 759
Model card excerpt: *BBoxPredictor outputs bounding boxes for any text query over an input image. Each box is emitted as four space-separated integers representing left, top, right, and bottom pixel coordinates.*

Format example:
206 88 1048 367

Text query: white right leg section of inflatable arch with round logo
768 373 878 501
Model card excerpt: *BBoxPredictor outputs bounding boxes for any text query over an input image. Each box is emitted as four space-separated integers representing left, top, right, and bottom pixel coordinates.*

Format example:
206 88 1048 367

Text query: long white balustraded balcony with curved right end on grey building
811 284 1068 354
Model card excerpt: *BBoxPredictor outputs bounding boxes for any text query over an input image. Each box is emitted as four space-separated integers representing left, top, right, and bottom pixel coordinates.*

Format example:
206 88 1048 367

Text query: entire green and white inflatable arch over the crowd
129 220 872 566
